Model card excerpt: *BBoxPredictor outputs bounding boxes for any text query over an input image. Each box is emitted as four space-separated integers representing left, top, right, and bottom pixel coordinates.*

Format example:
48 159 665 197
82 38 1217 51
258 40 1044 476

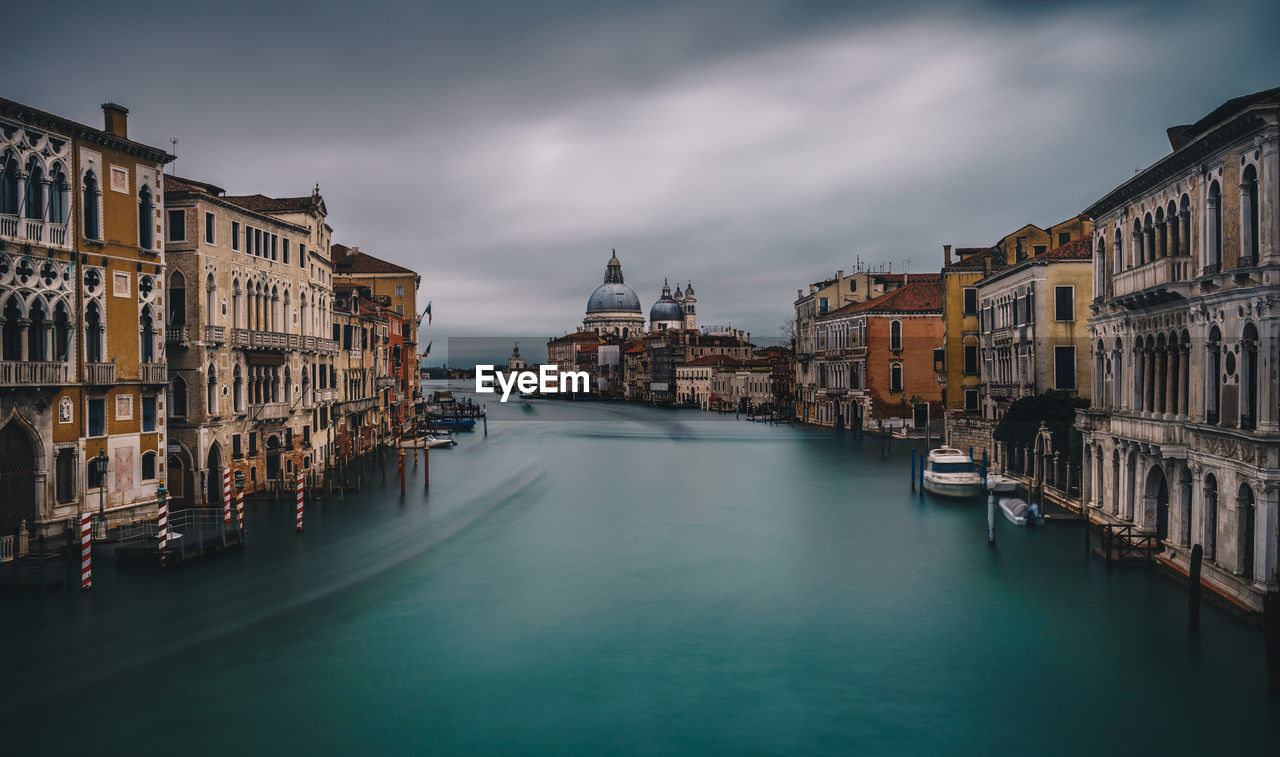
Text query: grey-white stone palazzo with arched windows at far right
1076 90 1280 610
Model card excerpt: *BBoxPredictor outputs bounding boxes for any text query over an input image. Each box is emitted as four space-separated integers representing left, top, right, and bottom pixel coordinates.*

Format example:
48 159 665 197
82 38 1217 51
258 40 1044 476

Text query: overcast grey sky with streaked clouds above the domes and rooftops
3 0 1280 362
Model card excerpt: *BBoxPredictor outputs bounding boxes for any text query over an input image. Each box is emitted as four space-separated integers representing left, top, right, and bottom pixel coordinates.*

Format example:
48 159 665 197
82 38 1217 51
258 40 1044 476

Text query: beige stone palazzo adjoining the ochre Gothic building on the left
165 177 337 507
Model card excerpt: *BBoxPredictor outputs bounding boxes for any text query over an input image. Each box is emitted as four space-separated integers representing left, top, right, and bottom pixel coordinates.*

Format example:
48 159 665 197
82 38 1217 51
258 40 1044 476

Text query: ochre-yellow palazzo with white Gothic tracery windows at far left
0 99 173 552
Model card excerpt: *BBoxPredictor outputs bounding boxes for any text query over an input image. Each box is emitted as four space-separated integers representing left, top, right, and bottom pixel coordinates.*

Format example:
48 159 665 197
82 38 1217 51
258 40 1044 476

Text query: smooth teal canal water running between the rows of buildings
0 386 1280 754
